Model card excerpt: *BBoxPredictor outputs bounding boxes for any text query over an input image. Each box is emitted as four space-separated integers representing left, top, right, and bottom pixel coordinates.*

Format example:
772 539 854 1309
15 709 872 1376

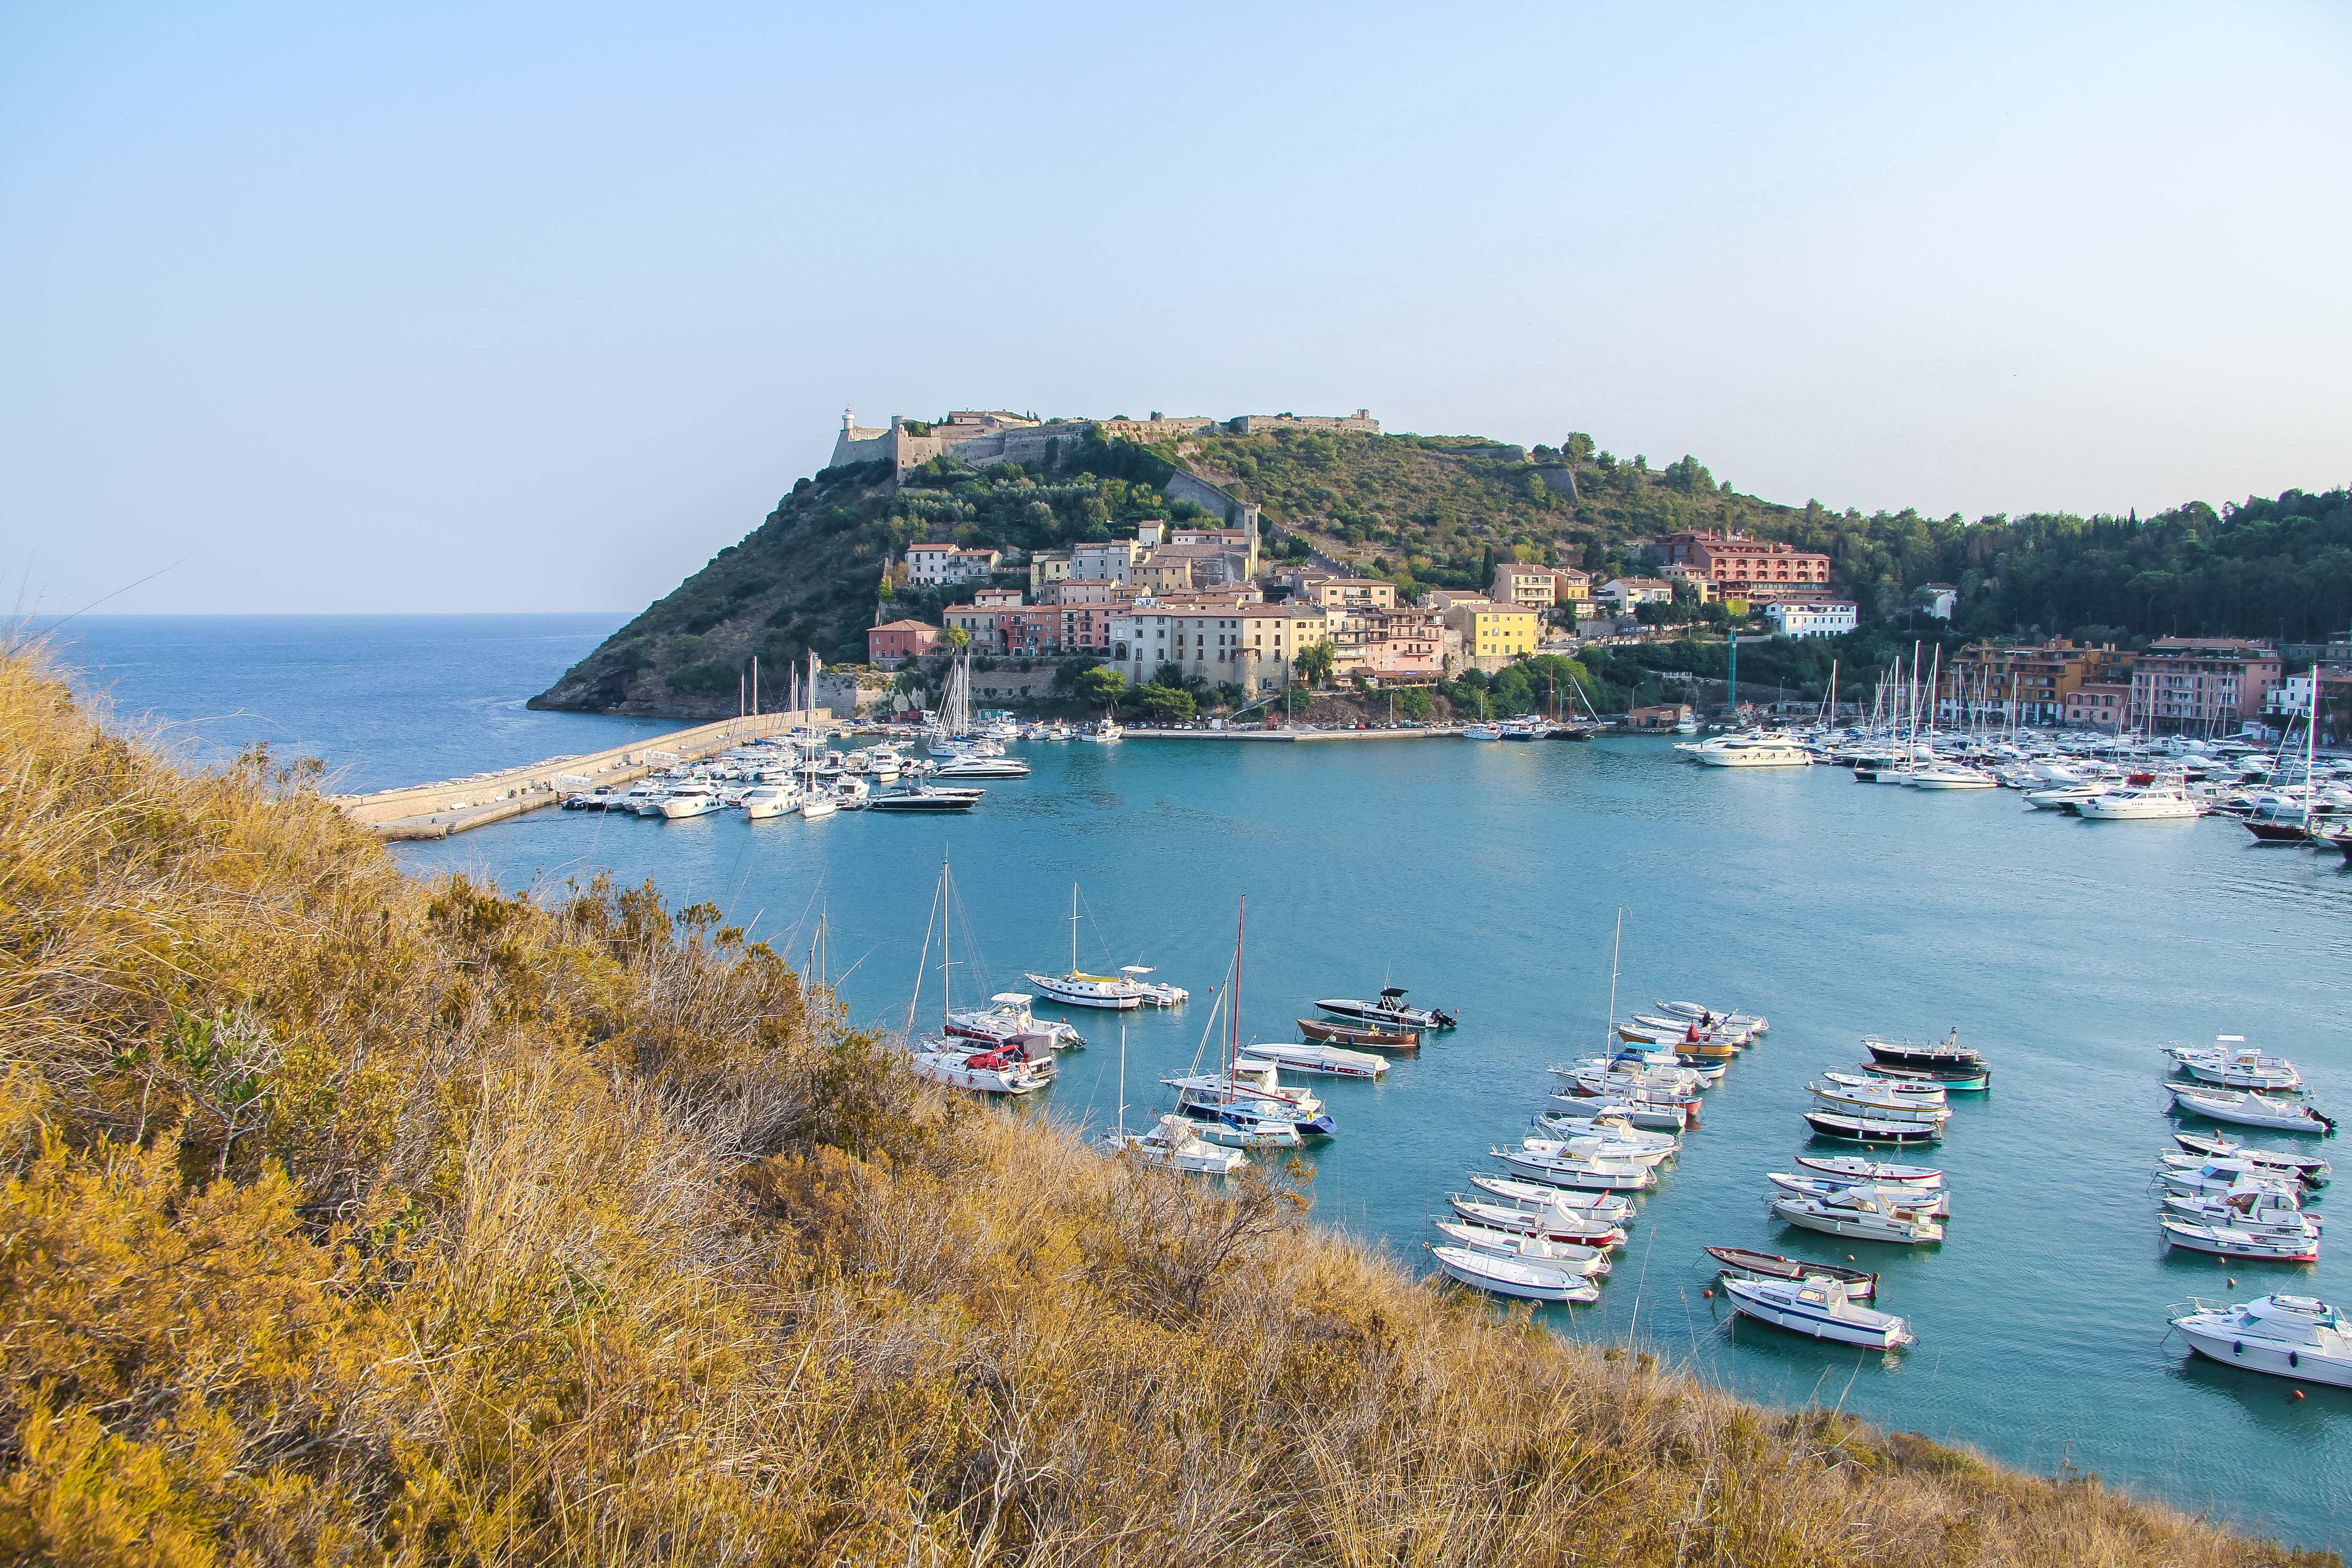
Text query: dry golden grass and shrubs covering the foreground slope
0 654 2333 1568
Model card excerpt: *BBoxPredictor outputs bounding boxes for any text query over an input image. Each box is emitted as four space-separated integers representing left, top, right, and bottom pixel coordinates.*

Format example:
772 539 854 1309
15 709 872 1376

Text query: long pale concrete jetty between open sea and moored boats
329 708 832 839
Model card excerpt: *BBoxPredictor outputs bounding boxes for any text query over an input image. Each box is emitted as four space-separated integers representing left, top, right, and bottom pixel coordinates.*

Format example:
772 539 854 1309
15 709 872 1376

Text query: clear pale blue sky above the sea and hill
0 0 2352 613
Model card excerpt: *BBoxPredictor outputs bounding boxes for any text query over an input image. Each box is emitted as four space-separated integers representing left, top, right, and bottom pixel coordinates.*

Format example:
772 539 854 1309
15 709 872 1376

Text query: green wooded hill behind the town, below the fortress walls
531 421 2352 717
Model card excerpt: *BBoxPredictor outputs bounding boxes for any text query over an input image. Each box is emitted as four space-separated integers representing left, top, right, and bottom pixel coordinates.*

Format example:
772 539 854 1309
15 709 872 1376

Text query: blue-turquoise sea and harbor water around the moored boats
37 616 2352 1549
